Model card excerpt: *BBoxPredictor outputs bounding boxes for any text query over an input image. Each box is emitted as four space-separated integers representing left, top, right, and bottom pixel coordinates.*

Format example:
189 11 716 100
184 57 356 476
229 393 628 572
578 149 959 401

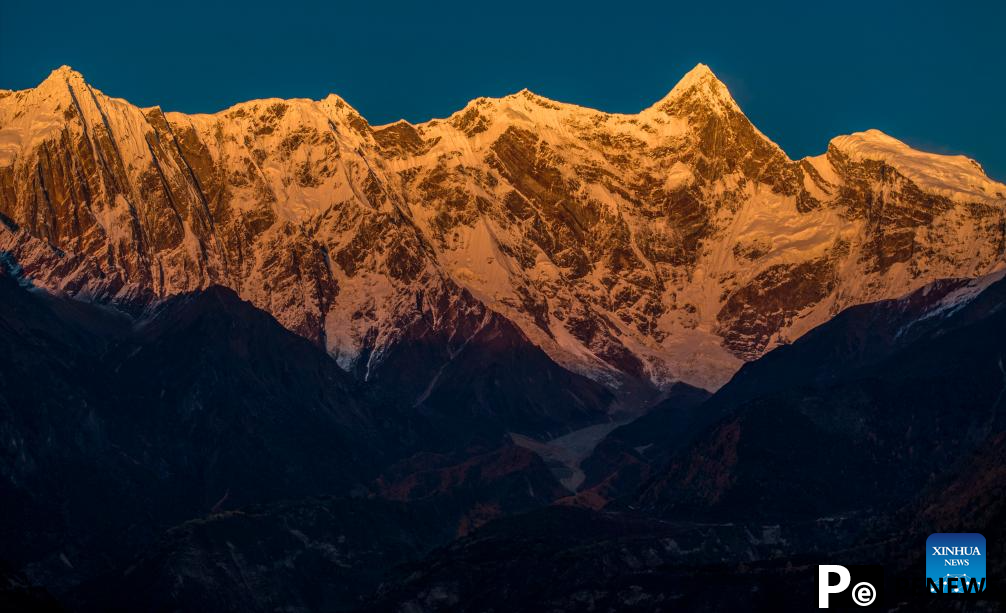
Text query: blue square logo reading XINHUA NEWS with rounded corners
926 532 988 596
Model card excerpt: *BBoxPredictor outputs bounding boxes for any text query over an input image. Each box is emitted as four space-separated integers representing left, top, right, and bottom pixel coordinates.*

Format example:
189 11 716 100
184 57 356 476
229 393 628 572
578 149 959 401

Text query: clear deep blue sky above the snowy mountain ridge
0 0 1006 179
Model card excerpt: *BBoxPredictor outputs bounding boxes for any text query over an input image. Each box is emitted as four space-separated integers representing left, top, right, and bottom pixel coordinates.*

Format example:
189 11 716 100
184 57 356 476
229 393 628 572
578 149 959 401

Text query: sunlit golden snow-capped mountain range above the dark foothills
0 64 1006 389
